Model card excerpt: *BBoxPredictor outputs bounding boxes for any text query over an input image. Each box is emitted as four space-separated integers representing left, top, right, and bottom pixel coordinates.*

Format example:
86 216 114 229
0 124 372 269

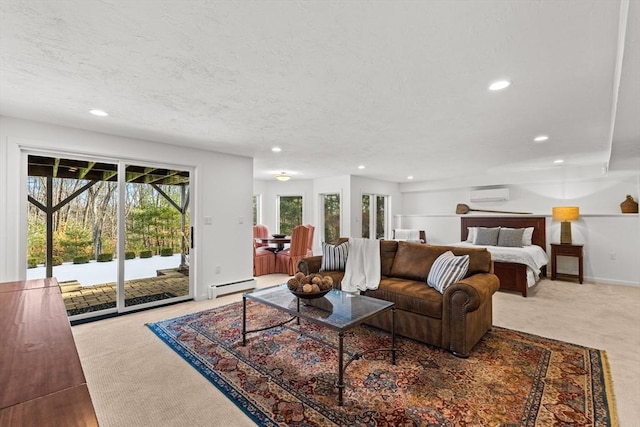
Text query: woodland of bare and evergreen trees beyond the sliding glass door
27 156 190 267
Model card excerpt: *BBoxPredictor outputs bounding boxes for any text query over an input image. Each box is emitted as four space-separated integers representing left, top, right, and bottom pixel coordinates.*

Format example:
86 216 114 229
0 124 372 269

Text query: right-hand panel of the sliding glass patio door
124 165 191 309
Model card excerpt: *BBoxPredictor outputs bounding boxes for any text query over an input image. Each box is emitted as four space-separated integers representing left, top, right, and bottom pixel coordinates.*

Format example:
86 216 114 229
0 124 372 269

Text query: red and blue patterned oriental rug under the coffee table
148 301 617 426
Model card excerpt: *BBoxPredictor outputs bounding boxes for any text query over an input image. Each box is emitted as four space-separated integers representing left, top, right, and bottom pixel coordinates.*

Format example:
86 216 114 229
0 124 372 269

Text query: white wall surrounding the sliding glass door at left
0 116 253 299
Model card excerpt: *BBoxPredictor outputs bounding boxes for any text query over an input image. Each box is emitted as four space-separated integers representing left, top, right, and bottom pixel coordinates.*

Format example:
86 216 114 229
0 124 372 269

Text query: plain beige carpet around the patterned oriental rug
73 275 640 427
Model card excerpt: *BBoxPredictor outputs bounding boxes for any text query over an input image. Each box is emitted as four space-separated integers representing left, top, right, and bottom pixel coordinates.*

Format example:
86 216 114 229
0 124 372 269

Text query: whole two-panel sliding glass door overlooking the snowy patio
26 154 192 320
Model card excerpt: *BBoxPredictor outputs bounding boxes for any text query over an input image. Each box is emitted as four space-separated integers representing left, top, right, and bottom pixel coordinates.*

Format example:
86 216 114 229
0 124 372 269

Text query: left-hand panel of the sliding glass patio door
26 155 118 318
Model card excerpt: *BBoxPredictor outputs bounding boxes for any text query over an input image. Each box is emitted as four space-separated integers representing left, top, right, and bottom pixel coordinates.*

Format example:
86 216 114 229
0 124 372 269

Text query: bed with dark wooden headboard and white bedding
456 215 549 297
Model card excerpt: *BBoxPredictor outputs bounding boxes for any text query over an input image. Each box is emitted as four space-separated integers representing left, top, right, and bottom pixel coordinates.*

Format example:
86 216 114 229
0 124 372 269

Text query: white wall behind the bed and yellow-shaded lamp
397 174 640 286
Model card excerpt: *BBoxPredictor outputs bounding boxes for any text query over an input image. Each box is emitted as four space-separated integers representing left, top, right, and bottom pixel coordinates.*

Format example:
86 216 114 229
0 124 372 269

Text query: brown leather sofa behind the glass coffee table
298 238 500 357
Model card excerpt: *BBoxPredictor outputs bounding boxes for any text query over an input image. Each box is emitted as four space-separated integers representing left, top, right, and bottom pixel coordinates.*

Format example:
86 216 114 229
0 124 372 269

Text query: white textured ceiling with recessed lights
0 0 640 182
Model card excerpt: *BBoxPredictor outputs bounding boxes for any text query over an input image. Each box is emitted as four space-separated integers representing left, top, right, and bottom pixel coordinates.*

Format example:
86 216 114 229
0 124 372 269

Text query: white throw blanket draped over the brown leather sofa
342 238 380 292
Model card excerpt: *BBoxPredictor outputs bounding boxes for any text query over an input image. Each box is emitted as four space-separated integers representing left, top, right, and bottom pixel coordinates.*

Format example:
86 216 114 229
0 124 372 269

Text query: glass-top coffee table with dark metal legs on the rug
242 284 396 405
